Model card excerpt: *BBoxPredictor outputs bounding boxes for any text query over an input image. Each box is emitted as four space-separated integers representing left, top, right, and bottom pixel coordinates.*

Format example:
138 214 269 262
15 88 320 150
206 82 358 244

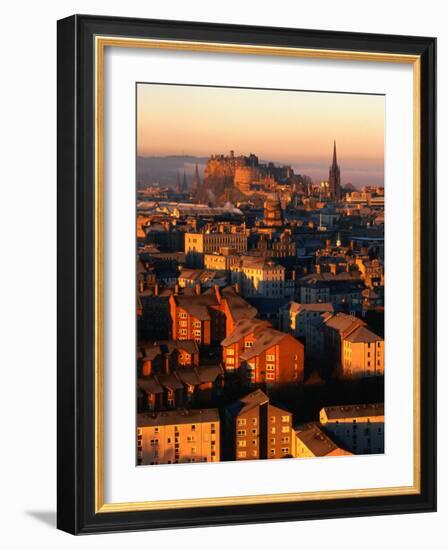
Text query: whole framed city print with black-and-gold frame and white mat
58 15 436 534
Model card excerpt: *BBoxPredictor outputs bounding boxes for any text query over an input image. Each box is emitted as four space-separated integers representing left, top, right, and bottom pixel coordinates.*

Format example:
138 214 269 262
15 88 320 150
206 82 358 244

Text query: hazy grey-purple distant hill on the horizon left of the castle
137 155 208 187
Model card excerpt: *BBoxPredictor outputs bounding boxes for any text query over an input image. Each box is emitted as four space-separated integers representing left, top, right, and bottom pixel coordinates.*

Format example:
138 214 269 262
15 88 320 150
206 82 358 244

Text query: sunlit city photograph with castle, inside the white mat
136 82 384 466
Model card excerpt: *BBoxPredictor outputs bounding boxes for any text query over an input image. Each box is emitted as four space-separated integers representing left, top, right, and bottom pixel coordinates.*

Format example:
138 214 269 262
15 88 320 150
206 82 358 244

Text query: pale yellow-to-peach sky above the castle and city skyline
137 84 385 187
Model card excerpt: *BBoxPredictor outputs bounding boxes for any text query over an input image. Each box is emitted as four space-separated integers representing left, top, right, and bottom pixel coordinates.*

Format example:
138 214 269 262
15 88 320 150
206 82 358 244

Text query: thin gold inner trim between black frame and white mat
94 36 421 513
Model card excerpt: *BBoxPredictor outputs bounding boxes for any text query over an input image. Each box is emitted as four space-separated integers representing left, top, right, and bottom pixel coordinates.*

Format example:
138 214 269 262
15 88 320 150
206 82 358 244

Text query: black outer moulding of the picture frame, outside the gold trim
57 15 436 534
